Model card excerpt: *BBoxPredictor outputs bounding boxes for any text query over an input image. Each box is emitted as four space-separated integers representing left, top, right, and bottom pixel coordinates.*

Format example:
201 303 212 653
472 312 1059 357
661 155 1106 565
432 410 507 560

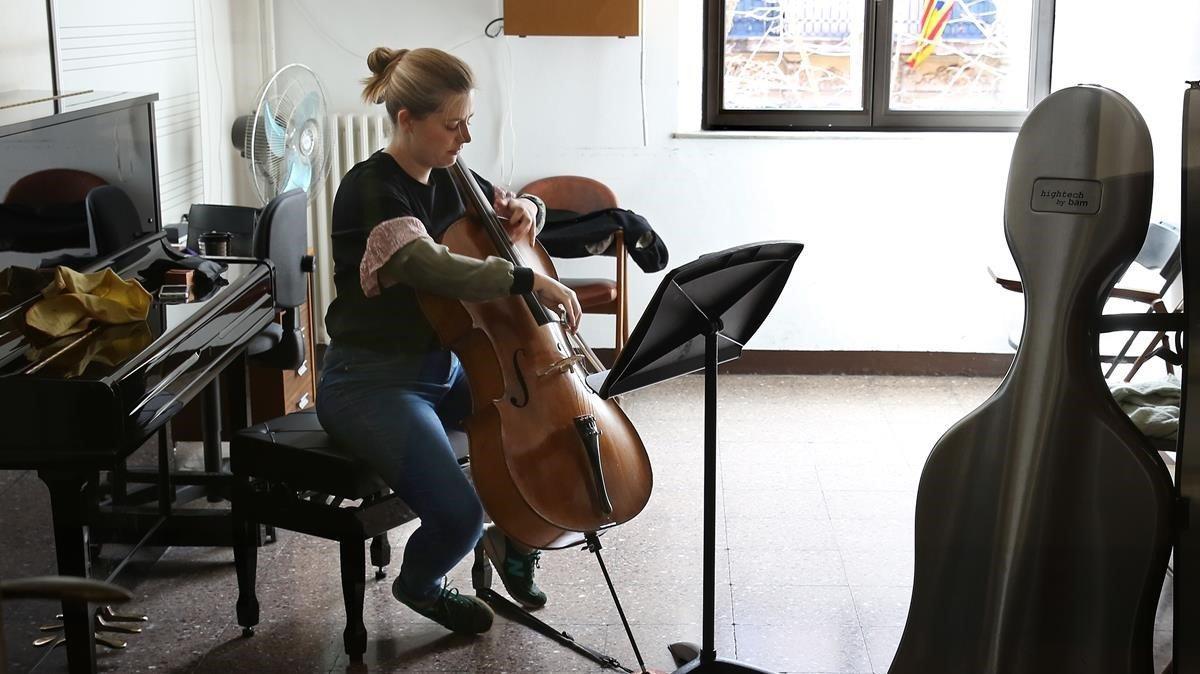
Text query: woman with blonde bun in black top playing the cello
317 48 581 633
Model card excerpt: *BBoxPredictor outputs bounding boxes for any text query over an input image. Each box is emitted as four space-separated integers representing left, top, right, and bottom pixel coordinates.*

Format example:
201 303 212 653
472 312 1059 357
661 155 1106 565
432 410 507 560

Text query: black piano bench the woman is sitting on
229 410 467 662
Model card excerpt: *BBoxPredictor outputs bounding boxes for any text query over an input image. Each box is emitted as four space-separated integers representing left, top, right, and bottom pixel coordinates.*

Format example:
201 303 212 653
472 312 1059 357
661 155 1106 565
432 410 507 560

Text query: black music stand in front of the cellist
588 241 804 674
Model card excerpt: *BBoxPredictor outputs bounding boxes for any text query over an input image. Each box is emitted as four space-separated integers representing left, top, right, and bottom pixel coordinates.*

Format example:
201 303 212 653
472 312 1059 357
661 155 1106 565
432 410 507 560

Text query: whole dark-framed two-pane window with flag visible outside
704 0 1054 131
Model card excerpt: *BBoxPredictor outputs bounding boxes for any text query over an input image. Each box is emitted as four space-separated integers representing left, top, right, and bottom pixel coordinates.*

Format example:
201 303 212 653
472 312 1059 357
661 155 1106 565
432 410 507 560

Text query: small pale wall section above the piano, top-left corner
0 0 52 91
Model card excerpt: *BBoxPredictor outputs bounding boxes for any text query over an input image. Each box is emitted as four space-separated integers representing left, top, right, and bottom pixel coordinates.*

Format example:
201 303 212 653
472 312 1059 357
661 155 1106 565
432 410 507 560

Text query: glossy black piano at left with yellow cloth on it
0 92 275 672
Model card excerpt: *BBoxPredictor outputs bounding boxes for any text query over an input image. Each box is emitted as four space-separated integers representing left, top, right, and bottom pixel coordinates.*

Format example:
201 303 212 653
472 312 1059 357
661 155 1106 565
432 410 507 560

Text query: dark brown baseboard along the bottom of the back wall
595 349 1013 377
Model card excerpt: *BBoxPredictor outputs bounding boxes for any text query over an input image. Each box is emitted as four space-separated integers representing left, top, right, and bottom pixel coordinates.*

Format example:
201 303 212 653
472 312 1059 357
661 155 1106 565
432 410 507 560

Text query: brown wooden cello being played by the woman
418 157 653 549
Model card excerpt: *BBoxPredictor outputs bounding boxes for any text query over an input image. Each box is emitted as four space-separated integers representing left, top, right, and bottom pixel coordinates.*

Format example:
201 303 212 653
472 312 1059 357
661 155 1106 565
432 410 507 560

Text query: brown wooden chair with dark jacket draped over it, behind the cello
520 175 629 360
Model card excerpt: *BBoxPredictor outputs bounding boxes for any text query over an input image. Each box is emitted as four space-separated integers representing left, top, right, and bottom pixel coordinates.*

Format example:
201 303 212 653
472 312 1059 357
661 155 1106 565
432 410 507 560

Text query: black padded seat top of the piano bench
229 410 388 499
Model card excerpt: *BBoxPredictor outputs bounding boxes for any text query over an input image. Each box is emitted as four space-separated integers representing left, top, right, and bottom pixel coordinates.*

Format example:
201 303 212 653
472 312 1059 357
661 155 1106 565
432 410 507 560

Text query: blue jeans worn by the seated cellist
317 344 484 598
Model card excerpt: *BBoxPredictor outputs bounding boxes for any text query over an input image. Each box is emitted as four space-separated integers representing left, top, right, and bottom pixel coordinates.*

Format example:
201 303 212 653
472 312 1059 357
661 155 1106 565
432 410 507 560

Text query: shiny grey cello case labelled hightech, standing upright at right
888 85 1171 674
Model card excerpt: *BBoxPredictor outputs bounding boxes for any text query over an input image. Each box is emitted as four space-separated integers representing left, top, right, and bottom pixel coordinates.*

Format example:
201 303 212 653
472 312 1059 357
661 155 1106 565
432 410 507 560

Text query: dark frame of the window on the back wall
701 0 1055 131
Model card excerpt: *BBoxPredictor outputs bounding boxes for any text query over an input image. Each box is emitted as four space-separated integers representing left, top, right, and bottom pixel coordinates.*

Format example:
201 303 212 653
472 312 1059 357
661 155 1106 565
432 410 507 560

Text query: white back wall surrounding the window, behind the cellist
275 0 1200 353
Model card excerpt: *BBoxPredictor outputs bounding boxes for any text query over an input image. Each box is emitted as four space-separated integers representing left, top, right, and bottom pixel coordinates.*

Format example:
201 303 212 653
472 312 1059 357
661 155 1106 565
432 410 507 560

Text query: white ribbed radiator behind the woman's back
308 114 391 344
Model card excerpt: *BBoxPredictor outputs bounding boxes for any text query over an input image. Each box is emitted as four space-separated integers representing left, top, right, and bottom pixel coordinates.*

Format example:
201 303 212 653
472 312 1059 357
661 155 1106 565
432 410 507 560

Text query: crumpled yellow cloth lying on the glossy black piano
25 266 150 337
